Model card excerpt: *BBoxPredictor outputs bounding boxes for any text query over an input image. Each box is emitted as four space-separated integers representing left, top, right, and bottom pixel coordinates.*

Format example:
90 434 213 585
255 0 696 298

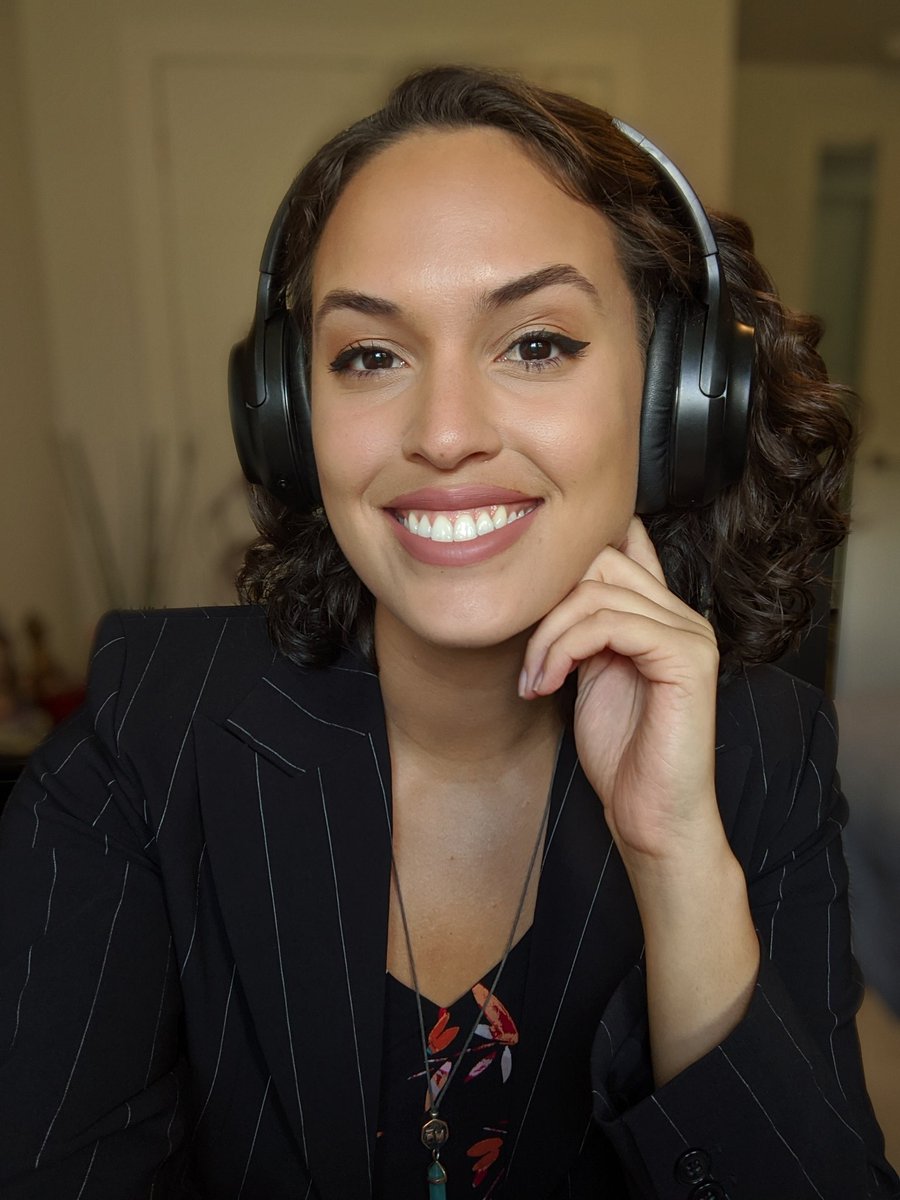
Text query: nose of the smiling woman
402 359 503 470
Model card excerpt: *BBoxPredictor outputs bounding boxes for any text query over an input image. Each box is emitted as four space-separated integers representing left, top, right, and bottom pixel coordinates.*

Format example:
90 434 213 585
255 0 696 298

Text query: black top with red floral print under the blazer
372 931 532 1200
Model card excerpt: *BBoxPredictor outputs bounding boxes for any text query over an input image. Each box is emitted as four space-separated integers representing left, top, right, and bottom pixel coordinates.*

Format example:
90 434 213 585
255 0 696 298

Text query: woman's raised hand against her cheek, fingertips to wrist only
522 517 724 864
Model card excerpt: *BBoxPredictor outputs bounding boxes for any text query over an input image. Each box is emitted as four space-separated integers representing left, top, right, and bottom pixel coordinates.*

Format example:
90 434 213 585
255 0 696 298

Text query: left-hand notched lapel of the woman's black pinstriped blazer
197 655 390 1200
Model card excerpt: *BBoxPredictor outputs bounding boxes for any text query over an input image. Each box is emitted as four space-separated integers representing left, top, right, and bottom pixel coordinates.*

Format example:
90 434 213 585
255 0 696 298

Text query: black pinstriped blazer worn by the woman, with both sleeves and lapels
0 608 898 1200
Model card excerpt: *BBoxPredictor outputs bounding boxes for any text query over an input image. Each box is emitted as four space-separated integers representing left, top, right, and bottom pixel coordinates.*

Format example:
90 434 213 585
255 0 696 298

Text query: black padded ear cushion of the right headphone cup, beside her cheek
635 296 684 515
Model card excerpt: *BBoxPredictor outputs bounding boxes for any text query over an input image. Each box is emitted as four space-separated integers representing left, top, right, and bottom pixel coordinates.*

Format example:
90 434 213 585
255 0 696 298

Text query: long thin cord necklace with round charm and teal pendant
391 738 562 1200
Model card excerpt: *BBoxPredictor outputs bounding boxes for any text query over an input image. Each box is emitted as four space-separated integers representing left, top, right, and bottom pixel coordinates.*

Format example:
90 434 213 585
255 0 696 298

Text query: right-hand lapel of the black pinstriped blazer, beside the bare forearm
504 733 643 1200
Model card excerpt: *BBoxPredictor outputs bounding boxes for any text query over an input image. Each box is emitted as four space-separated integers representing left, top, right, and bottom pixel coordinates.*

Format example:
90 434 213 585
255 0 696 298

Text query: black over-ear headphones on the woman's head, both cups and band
228 120 754 515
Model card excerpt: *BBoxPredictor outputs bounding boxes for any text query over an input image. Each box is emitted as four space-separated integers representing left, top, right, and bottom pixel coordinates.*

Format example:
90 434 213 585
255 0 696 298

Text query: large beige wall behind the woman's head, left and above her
0 0 734 662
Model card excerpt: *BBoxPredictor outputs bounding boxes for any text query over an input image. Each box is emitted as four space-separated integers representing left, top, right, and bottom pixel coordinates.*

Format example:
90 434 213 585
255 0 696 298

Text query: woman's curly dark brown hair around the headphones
238 67 853 673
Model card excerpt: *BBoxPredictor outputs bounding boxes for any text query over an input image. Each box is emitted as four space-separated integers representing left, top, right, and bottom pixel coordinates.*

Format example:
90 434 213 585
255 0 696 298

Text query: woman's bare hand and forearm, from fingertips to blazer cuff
522 518 760 1085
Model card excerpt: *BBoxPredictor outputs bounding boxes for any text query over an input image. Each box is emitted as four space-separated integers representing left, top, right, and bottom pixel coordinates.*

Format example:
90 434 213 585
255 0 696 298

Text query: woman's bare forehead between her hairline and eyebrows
313 127 624 299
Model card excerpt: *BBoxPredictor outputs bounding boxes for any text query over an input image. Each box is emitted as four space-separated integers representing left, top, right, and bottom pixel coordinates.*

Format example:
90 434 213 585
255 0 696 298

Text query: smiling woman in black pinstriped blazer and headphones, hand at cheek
0 67 898 1200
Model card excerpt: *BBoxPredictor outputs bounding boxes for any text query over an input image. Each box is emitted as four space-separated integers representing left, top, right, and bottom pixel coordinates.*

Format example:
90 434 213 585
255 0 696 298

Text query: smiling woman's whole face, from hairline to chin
312 128 643 647
